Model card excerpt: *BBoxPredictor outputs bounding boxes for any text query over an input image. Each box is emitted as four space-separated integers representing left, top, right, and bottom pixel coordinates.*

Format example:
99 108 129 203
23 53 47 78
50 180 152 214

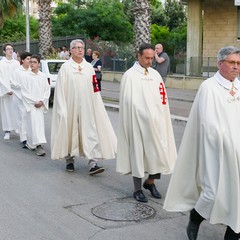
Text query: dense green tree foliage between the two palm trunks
53 0 133 42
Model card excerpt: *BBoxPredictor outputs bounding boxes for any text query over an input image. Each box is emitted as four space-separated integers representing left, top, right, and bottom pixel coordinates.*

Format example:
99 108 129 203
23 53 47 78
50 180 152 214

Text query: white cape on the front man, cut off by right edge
164 73 240 232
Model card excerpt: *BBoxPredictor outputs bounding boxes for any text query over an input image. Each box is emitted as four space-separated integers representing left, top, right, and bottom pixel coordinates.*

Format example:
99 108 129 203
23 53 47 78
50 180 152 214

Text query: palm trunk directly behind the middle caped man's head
133 0 151 53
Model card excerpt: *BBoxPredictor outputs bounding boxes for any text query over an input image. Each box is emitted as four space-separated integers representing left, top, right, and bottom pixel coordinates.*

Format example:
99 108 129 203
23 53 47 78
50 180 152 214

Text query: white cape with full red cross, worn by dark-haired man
116 62 177 178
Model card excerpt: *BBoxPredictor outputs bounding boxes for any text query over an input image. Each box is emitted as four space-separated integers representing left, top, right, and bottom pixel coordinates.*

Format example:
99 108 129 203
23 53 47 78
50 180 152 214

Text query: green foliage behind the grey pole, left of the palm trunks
0 14 38 42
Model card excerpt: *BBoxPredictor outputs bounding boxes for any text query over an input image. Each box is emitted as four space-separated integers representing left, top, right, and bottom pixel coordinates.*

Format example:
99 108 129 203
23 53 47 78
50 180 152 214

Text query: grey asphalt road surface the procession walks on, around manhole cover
0 106 225 240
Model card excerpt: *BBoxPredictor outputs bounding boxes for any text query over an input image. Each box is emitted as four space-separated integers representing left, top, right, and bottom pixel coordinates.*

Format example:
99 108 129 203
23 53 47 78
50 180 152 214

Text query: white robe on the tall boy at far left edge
0 57 20 131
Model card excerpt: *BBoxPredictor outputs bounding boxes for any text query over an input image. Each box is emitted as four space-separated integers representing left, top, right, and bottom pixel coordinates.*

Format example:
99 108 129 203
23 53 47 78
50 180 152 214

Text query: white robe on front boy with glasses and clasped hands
21 71 50 148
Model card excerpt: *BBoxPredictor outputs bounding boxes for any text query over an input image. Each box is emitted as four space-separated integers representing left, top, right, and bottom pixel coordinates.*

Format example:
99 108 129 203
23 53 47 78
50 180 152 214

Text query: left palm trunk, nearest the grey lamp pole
38 0 52 58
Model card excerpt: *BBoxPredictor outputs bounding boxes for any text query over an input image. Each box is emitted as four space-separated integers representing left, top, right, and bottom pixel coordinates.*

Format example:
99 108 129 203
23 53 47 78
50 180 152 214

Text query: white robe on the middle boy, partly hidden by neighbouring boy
10 65 31 142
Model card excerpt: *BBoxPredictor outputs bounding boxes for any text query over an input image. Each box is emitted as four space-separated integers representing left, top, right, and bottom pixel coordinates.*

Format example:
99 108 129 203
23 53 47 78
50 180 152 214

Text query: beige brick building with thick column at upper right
181 0 240 75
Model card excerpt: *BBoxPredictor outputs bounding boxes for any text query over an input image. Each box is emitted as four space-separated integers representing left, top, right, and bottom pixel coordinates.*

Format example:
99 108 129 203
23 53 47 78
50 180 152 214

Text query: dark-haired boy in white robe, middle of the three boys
10 52 32 148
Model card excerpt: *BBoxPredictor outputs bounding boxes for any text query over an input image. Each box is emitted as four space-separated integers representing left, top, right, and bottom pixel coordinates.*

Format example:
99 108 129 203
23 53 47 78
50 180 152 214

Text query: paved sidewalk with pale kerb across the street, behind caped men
101 81 197 124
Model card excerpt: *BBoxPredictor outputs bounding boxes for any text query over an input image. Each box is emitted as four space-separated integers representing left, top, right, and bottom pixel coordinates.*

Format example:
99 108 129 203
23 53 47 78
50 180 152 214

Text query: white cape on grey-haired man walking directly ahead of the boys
51 59 117 159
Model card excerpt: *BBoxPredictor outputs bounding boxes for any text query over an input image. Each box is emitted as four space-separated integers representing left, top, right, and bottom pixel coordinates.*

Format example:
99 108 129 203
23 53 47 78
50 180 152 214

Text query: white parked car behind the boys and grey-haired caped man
41 59 66 102
